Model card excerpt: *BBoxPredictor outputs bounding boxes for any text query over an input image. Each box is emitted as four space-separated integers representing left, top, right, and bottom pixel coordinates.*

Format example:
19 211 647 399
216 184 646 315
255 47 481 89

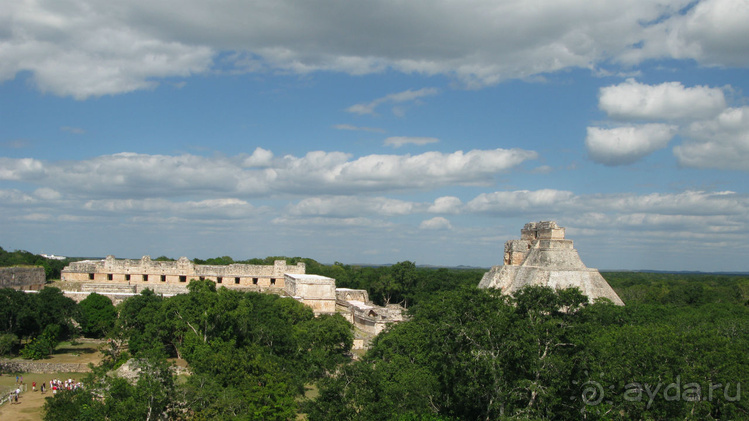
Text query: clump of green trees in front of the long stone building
45 280 353 420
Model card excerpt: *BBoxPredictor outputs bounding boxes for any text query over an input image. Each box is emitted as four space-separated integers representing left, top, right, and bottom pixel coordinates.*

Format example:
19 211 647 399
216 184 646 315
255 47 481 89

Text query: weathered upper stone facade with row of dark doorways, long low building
61 255 306 291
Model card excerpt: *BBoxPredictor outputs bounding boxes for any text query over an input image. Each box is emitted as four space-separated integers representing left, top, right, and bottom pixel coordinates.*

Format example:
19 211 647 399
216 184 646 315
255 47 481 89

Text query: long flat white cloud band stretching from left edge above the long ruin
0 148 537 198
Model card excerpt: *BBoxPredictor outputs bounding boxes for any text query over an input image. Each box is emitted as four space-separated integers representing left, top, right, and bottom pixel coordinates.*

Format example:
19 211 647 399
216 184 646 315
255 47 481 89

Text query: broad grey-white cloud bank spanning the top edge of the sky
7 0 749 97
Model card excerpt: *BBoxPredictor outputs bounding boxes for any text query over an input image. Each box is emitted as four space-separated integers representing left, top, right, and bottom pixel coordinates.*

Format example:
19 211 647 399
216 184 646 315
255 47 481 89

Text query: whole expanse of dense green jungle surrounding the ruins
0 249 749 421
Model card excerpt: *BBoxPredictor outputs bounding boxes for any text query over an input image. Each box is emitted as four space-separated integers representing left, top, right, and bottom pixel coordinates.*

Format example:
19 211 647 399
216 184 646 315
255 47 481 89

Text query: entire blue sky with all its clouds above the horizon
0 0 749 271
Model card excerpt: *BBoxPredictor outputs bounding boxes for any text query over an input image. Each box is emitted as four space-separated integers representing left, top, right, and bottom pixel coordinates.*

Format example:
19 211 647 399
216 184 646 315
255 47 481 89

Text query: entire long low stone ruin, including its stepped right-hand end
61 255 403 340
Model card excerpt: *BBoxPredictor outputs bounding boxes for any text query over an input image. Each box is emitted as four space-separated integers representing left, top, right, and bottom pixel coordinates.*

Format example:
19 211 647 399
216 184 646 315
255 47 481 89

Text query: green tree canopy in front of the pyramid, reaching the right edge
307 287 749 420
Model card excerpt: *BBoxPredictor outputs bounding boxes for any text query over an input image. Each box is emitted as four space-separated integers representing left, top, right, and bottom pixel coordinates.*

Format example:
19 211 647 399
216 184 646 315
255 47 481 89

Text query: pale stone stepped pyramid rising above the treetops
479 221 624 306
